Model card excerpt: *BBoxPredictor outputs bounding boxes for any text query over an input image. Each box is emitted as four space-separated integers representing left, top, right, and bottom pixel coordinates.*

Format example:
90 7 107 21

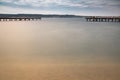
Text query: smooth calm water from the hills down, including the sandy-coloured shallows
0 18 120 80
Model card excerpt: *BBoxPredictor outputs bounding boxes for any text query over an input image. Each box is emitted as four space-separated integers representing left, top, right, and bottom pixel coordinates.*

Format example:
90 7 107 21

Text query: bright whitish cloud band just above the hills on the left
0 6 64 14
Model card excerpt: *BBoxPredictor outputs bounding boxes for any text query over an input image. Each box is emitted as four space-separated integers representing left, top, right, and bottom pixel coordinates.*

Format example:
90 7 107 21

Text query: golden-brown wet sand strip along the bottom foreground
0 63 120 80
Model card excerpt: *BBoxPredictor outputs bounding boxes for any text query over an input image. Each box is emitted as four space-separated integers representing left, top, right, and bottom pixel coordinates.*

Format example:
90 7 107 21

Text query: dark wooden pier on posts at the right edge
86 16 120 22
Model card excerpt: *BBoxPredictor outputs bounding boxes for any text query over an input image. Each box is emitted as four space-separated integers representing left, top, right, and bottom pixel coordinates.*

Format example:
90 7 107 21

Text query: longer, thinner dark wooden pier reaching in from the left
0 17 41 21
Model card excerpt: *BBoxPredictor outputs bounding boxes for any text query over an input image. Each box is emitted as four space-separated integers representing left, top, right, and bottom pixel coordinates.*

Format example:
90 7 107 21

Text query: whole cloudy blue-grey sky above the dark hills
0 0 120 16
